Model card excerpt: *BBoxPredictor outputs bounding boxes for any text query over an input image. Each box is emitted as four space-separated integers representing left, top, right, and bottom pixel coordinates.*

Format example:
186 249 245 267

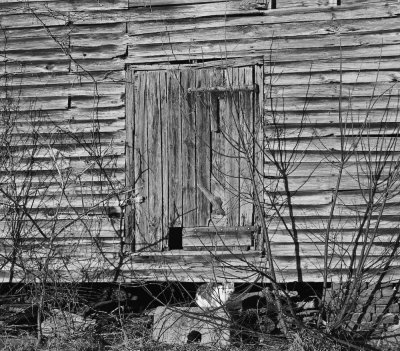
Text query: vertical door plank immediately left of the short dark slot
194 70 212 226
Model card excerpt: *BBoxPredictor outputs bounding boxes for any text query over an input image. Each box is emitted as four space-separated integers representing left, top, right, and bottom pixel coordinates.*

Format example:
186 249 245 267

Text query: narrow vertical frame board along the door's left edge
124 70 137 250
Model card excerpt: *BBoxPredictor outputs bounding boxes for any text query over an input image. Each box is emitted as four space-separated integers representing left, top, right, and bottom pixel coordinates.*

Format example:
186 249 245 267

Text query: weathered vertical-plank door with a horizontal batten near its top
127 66 262 250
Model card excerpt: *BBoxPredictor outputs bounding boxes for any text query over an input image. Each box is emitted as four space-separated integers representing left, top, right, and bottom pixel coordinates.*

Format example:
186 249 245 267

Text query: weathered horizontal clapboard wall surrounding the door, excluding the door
0 0 400 281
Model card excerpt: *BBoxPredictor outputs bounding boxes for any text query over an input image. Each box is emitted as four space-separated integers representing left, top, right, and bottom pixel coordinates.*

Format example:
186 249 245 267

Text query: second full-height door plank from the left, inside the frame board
146 71 162 250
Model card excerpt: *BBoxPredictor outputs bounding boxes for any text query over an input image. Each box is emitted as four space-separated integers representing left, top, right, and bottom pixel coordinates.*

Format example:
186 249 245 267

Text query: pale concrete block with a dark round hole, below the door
153 307 230 346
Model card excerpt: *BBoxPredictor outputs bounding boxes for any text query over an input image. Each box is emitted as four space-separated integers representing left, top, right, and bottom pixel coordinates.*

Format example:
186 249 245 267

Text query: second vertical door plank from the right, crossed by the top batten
225 68 240 226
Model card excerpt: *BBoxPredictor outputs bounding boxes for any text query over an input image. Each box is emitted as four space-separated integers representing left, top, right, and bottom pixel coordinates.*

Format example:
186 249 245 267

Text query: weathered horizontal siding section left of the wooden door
0 0 128 281
